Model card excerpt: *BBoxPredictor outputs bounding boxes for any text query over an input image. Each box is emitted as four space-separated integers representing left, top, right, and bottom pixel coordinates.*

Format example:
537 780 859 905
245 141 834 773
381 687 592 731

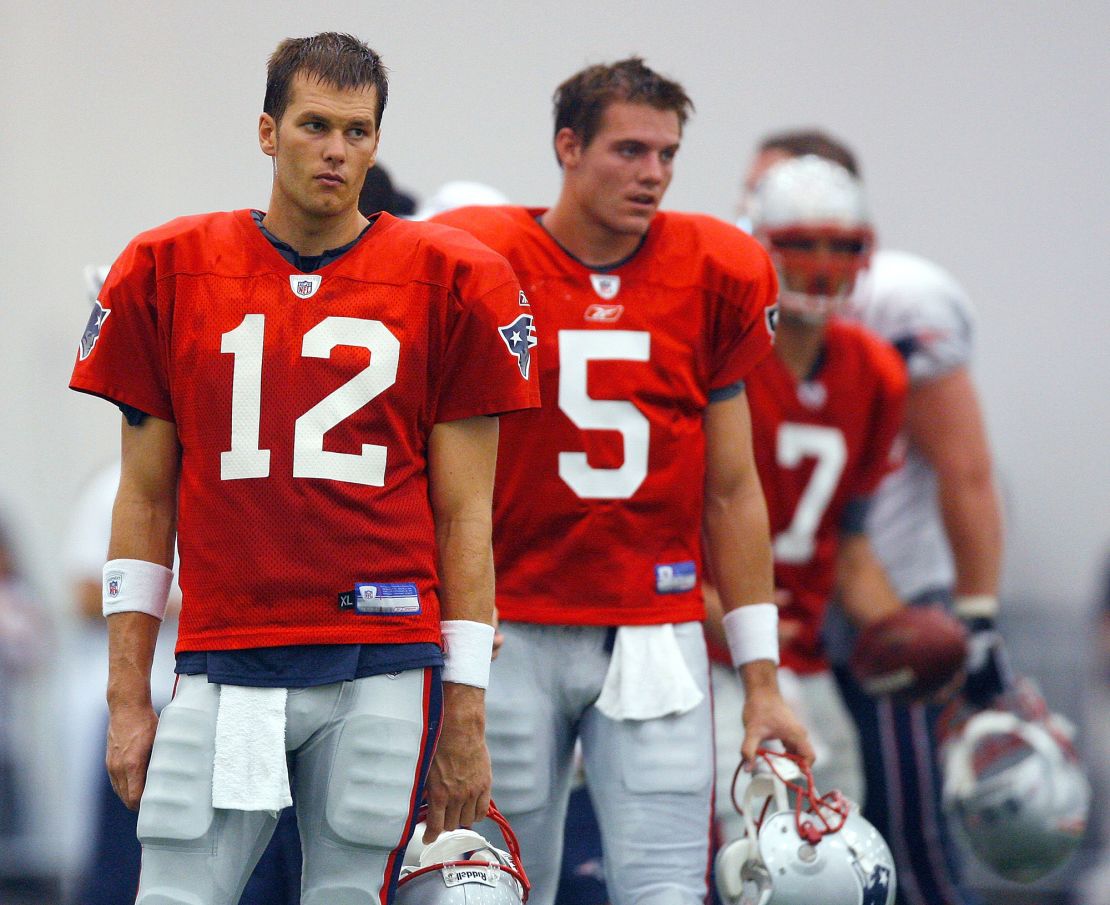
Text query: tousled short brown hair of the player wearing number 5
552 57 694 163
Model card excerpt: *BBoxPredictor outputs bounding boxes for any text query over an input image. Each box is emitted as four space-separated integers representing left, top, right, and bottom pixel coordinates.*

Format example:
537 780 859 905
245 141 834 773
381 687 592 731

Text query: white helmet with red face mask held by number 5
715 748 896 905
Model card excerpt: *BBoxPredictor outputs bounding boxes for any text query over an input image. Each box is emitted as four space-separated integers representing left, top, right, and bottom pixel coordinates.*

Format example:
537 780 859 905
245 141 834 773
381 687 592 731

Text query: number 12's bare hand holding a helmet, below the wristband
424 682 493 845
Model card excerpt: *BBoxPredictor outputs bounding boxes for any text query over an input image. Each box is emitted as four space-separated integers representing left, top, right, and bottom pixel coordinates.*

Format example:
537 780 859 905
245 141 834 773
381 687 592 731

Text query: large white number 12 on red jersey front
220 314 401 487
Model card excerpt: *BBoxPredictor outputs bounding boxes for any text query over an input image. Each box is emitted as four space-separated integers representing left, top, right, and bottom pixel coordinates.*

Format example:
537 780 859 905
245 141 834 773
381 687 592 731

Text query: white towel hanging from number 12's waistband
212 685 293 815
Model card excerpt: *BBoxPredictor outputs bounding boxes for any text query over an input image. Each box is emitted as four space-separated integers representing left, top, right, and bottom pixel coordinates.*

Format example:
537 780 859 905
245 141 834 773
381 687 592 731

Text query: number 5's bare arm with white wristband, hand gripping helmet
704 393 814 764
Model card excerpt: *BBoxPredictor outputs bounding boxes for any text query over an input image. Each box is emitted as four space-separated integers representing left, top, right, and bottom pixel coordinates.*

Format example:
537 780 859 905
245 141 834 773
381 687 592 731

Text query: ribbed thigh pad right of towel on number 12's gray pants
324 714 424 848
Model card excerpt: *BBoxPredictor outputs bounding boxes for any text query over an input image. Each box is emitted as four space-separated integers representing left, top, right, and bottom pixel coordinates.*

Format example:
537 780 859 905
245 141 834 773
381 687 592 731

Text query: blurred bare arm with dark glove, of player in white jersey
906 366 1010 706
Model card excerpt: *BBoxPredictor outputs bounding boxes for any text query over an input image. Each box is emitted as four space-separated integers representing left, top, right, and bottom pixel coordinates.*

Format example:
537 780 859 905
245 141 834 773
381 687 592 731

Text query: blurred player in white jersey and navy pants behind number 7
745 132 1008 905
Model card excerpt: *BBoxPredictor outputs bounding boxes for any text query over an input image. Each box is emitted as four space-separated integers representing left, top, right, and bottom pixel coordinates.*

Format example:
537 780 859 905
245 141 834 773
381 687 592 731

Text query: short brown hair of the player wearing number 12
262 31 390 128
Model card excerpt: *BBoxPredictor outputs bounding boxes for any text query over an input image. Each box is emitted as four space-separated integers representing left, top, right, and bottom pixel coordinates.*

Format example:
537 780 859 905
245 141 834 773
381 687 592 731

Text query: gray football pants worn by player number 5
480 622 713 905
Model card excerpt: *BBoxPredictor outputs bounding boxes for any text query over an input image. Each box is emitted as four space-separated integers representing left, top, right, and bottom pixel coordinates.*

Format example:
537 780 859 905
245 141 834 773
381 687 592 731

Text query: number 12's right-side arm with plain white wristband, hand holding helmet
424 415 497 842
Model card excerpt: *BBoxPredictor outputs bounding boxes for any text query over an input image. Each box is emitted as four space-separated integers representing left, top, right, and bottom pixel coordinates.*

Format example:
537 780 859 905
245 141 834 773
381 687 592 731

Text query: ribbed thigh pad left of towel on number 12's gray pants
138 704 215 843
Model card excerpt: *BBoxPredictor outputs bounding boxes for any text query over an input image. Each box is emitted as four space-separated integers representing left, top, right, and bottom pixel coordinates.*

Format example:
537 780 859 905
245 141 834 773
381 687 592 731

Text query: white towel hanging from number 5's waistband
597 623 705 720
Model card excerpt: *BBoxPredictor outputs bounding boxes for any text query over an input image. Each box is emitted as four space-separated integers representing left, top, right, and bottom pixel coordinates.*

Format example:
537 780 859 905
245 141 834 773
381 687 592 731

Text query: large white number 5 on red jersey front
558 330 652 500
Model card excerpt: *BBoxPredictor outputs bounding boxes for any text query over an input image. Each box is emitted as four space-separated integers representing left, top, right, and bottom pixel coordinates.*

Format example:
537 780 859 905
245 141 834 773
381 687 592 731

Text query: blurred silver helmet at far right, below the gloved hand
941 680 1091 883
